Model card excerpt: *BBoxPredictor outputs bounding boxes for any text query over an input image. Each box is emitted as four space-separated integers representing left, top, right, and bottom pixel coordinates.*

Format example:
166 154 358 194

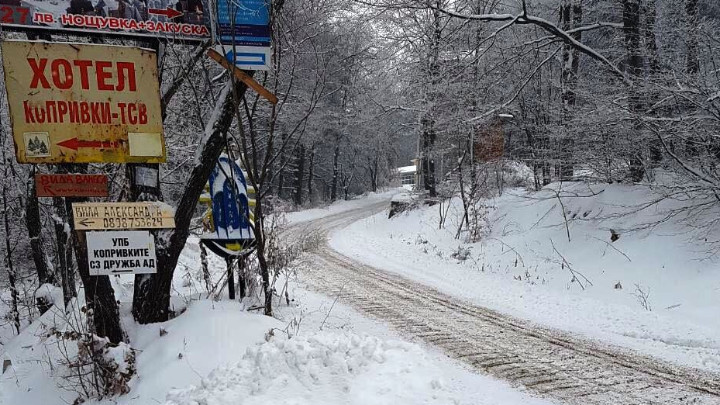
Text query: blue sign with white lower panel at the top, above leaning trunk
216 0 270 70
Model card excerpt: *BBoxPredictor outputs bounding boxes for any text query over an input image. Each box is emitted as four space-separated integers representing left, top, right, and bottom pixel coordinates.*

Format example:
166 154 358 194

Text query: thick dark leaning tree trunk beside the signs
133 80 252 324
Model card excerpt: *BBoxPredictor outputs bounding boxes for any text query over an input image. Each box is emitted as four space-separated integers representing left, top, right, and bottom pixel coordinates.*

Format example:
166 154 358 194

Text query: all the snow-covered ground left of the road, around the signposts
0 192 547 405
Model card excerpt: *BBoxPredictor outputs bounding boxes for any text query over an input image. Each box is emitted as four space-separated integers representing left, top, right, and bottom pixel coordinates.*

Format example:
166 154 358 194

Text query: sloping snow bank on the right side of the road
330 183 720 371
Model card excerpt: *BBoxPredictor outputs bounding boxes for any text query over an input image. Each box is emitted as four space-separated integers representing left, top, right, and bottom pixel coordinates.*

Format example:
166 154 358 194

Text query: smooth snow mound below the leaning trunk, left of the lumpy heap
108 300 284 405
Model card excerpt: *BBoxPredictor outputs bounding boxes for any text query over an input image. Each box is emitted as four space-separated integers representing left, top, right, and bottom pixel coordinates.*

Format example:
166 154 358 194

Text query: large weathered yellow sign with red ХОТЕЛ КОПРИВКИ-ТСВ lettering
2 41 165 163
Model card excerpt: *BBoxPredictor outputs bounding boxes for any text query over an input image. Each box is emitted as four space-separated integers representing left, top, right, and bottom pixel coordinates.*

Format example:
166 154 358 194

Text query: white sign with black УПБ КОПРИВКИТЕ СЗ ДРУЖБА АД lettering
87 231 157 276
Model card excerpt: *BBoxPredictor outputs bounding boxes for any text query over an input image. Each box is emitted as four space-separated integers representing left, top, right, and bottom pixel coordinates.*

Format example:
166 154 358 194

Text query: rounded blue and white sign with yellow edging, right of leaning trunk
202 154 255 257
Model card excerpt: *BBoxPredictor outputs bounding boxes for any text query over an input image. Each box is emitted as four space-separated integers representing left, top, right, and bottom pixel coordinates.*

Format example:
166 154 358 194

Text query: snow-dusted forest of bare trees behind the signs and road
0 0 720 356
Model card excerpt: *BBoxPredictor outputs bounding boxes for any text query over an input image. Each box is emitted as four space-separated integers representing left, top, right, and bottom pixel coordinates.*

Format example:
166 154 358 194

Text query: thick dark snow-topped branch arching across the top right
429 6 633 85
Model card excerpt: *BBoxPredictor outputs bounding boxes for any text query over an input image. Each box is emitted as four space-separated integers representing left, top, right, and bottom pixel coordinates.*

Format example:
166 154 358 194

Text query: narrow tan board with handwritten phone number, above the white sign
72 202 175 231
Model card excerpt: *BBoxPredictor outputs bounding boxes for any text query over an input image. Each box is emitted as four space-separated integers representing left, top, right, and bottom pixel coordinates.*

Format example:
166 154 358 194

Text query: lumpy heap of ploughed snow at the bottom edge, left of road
167 332 486 405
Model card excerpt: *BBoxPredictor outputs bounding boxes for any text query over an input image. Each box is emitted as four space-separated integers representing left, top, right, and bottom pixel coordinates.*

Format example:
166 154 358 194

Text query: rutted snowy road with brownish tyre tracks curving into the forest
289 201 720 405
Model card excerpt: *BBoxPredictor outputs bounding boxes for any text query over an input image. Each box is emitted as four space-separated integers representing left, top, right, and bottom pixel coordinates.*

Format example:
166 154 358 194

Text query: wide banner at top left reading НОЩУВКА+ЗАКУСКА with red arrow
0 0 211 41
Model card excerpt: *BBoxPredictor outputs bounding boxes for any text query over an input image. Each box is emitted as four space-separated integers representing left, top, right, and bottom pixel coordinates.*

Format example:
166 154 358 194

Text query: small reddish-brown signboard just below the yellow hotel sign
35 174 108 197
